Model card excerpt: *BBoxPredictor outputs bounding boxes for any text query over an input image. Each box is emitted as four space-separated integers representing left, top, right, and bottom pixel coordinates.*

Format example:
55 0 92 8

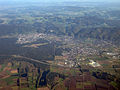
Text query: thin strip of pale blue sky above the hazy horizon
0 0 120 5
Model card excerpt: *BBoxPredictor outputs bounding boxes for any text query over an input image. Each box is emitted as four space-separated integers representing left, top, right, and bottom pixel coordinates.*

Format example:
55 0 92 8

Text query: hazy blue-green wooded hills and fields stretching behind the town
0 0 120 45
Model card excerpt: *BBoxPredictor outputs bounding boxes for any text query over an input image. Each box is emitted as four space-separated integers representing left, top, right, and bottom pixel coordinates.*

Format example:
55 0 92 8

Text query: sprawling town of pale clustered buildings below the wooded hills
16 33 120 67
